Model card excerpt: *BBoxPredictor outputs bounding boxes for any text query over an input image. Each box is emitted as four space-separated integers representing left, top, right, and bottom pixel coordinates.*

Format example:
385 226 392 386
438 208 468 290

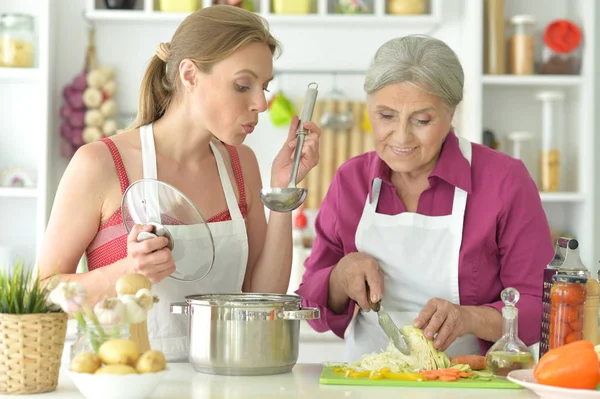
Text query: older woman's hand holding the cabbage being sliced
413 298 469 351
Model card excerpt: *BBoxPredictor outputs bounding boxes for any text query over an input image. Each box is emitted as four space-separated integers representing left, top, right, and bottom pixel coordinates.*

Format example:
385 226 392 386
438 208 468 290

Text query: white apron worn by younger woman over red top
140 125 248 362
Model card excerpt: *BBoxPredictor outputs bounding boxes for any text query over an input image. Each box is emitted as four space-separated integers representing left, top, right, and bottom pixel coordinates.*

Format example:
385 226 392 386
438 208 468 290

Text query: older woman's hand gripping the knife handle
329 252 383 312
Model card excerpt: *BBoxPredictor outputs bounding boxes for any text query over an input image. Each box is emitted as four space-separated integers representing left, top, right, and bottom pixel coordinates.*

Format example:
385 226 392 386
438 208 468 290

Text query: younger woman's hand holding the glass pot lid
127 224 175 284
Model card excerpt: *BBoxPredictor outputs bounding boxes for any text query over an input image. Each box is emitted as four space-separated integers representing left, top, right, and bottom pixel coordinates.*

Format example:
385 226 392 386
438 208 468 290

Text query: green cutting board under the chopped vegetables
319 367 523 389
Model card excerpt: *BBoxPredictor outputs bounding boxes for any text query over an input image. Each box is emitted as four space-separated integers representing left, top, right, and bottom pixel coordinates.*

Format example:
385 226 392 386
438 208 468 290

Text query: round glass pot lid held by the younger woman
121 179 215 281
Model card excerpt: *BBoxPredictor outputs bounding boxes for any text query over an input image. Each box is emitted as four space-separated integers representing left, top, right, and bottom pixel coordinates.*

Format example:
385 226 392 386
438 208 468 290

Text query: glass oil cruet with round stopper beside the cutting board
485 287 534 377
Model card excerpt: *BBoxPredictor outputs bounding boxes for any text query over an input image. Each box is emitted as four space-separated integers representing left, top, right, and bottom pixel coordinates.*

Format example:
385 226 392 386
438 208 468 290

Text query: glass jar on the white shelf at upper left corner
0 14 34 68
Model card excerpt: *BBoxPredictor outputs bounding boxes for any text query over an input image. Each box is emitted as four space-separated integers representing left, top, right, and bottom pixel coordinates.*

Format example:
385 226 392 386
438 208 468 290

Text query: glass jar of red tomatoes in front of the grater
549 274 587 349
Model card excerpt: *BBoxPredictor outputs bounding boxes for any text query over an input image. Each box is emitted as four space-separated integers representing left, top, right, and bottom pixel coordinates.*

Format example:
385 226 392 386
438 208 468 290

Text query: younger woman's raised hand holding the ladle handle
271 115 321 187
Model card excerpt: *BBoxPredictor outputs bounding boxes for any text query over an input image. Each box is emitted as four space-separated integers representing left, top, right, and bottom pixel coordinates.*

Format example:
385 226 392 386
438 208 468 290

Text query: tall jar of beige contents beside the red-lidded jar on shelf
508 15 535 75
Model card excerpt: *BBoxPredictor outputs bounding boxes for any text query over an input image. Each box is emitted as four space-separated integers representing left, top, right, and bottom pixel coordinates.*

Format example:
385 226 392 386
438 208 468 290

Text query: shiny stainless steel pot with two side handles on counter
171 293 320 375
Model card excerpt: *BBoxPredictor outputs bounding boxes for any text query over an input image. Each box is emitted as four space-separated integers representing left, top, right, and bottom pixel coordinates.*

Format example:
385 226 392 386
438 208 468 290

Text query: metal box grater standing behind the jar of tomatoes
539 237 598 358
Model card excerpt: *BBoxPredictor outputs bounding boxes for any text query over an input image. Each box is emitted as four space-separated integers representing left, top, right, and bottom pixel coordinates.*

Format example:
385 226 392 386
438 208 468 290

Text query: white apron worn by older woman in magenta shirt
345 138 481 361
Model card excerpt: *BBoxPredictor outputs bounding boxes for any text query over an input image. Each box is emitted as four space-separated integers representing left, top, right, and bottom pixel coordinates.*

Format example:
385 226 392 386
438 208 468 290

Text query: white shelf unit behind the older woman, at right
457 0 600 276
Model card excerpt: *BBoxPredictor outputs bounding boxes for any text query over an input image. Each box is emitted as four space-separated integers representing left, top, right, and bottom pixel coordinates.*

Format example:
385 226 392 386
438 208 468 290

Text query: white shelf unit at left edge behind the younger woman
0 0 53 265
